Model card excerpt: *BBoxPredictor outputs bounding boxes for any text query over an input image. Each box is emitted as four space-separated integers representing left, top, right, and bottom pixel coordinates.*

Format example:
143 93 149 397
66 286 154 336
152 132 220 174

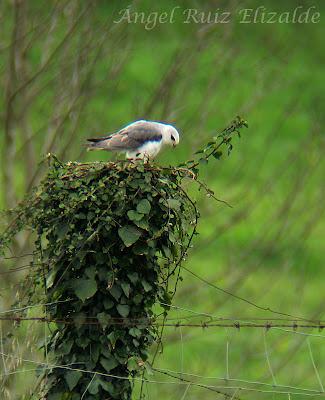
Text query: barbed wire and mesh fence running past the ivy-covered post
0 254 325 400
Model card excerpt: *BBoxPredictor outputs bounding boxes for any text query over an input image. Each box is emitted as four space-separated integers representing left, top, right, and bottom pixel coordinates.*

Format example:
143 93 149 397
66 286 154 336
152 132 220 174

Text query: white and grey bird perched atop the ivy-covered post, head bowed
87 120 179 159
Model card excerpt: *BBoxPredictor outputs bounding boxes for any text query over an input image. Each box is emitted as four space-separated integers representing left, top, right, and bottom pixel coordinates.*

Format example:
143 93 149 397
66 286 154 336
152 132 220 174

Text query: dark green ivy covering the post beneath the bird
0 118 246 400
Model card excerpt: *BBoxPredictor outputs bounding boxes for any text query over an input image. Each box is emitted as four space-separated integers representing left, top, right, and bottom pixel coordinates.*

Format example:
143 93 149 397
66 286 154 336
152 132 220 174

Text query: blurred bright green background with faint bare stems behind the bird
0 0 325 400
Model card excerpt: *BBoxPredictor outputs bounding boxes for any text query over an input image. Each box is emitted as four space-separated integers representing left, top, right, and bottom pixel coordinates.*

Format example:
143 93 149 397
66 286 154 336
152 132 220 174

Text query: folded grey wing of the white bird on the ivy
105 122 162 151
